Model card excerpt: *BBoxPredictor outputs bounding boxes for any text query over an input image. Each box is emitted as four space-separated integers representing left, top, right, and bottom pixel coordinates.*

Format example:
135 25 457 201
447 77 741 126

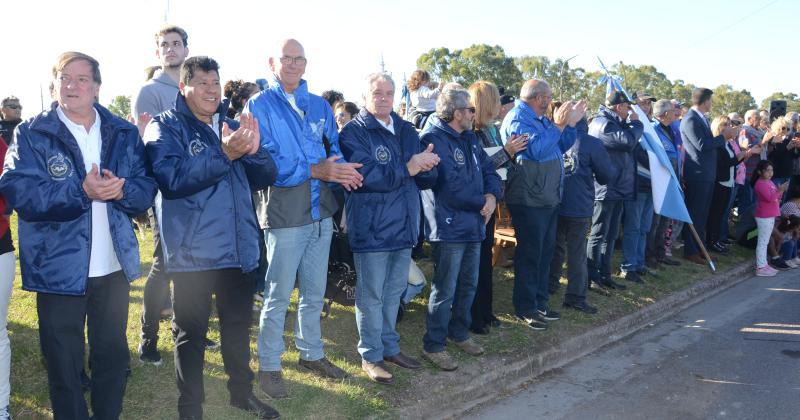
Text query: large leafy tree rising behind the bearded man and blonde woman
417 44 522 92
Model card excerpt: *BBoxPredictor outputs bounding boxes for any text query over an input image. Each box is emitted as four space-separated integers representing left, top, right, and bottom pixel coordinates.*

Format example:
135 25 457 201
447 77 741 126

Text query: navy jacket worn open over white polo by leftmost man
0 102 156 296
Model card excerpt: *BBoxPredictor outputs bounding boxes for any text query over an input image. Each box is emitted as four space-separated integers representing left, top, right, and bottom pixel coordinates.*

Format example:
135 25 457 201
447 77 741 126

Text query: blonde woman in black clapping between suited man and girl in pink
706 116 761 253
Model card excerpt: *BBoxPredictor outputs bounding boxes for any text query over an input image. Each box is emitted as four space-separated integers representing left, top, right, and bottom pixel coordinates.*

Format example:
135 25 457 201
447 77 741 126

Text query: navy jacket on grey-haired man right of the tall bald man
339 109 436 252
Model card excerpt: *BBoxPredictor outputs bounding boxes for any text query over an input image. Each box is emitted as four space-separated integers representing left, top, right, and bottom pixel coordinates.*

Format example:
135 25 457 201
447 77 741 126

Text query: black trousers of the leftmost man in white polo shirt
36 271 130 420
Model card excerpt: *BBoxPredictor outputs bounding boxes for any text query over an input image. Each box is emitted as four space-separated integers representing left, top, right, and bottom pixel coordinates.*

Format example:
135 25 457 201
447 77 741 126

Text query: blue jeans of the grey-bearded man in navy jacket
422 242 481 353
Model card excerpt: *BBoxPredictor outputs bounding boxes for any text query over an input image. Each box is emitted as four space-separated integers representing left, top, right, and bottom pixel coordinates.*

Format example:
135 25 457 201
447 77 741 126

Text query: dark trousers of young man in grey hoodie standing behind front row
142 221 170 342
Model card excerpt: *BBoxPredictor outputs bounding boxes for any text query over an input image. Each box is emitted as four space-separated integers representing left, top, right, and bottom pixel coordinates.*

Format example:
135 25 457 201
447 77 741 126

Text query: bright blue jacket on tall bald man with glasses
243 75 343 228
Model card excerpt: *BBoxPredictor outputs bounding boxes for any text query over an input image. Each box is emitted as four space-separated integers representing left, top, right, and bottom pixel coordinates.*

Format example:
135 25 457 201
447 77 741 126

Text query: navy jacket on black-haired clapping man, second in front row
144 95 276 273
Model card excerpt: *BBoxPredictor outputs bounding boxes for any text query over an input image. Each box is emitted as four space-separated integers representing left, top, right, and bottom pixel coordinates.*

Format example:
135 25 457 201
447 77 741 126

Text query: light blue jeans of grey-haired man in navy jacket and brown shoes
353 248 411 363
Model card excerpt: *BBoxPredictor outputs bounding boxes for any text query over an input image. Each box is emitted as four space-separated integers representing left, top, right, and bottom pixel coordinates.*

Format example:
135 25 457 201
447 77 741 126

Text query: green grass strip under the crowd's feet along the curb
8 216 753 419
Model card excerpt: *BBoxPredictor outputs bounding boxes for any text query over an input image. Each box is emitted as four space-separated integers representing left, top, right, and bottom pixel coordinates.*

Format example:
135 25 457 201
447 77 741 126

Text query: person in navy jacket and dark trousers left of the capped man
550 116 619 314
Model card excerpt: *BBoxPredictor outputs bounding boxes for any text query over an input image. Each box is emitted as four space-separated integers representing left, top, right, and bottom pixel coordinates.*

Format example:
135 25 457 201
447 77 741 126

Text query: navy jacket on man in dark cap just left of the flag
589 105 644 201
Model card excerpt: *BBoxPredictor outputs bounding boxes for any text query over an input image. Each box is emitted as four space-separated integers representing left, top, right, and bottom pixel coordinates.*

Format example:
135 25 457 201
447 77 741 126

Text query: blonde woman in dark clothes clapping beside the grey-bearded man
469 81 528 334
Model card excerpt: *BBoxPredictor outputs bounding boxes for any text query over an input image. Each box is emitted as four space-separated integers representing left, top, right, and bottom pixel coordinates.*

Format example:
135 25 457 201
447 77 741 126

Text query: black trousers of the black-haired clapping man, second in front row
171 269 254 417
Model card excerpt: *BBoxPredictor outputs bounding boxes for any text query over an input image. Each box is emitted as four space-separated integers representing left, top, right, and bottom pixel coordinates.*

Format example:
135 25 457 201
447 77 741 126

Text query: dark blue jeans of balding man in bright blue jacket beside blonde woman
508 204 558 318
